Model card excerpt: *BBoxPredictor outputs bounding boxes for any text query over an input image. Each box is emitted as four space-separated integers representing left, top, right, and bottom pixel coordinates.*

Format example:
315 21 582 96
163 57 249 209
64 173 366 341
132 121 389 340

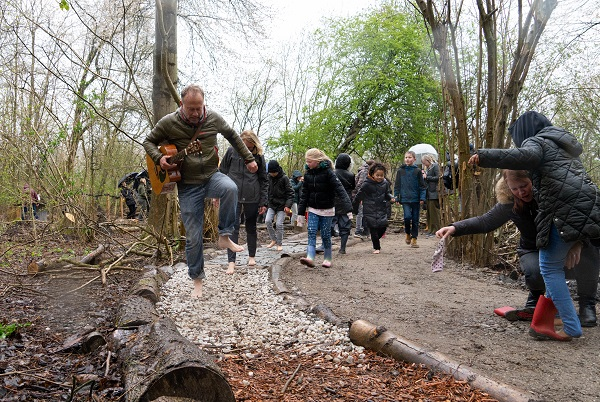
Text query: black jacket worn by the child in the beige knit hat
298 161 352 216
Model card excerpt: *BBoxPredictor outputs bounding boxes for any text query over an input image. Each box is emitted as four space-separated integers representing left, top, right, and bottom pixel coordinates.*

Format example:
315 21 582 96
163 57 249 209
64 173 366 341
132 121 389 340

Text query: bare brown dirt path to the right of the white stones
281 233 600 402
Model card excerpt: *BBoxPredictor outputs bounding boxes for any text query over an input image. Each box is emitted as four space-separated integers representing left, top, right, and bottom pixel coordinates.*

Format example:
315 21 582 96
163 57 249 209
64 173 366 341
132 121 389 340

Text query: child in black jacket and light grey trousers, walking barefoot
265 160 294 251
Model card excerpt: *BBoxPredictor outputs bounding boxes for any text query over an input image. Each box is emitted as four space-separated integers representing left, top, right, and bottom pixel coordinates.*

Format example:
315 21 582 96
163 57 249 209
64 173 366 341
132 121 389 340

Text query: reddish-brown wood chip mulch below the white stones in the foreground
217 351 496 402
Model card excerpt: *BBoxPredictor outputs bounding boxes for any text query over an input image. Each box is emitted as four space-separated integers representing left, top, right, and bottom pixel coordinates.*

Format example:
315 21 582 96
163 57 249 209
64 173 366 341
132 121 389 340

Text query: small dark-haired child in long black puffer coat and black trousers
352 162 395 254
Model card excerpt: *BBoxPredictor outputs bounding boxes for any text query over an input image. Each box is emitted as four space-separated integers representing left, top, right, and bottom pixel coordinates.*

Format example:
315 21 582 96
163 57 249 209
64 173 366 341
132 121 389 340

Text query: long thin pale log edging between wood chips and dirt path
349 320 540 402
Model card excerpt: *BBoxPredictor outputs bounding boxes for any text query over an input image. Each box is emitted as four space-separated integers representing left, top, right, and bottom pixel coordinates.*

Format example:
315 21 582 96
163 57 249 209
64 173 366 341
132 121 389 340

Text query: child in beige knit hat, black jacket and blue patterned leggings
298 148 352 268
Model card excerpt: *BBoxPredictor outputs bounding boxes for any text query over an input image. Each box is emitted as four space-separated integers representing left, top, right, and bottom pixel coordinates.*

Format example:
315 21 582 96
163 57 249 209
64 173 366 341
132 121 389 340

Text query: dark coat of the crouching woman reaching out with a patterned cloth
452 178 538 255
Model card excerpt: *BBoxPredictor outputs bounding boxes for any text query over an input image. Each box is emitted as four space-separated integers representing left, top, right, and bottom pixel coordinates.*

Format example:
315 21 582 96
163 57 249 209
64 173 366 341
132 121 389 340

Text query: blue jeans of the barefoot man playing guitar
177 172 238 279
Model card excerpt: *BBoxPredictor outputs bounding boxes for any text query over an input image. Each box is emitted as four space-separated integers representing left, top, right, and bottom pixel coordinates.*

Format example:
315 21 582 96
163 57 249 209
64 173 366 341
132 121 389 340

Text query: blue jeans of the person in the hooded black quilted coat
540 224 583 337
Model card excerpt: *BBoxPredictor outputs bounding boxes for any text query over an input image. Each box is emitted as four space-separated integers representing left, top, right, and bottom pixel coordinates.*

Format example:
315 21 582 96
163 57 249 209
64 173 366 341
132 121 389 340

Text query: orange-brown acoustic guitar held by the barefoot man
146 140 202 194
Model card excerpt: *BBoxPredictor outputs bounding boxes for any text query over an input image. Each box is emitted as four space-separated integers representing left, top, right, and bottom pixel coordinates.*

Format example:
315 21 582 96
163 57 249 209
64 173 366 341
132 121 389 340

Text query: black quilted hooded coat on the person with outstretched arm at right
477 112 600 248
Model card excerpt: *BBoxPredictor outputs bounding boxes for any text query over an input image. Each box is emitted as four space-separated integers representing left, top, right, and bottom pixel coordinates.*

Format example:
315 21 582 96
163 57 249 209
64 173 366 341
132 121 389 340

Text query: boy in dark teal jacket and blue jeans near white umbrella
394 151 427 248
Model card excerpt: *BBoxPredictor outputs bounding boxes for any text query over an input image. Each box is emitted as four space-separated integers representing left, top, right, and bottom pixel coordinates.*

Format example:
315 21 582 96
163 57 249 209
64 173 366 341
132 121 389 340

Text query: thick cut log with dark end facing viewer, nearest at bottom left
115 318 235 402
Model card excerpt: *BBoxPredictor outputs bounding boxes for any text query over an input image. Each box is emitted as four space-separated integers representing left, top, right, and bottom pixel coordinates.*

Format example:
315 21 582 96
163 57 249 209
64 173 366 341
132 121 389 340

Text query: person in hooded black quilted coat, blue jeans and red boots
469 111 600 341
